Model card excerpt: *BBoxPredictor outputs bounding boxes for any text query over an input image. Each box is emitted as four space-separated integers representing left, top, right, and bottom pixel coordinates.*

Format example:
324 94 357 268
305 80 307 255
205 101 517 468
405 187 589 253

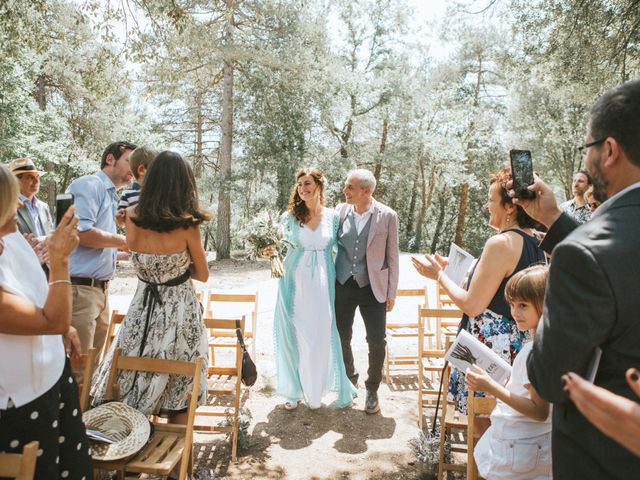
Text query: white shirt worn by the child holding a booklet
491 342 551 439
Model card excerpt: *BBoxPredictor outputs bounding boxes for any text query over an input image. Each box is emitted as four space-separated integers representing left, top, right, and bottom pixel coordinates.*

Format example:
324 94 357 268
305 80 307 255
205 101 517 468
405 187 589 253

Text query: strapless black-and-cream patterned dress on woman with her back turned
91 251 209 415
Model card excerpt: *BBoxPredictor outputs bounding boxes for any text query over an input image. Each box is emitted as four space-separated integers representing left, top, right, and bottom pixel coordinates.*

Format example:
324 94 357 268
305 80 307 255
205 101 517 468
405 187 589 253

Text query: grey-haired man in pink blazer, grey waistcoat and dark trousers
335 169 399 413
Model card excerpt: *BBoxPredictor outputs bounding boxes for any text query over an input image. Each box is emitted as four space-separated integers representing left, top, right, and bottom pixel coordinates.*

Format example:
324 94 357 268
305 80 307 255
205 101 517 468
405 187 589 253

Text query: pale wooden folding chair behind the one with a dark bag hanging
204 292 258 362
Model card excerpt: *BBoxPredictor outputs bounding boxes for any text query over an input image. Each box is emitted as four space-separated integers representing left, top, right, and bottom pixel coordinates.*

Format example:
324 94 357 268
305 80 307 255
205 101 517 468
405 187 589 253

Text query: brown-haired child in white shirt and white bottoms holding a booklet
466 265 552 480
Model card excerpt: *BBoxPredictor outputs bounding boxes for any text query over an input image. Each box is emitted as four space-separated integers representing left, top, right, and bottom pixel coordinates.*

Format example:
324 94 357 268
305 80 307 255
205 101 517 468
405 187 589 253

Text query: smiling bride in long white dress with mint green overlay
274 169 356 410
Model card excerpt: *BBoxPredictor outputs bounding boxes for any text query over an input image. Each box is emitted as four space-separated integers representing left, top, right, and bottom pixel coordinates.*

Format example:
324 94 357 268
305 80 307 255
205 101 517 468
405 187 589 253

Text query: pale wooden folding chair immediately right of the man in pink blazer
385 287 428 384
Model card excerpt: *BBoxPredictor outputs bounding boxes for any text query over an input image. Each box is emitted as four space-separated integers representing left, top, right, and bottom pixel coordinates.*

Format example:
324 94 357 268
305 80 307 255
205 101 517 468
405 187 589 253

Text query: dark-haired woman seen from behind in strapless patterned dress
91 151 210 423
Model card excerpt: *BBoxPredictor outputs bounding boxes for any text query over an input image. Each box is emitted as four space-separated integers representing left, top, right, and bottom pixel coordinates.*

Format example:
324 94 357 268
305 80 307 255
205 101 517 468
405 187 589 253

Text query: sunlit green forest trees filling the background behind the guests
0 0 640 255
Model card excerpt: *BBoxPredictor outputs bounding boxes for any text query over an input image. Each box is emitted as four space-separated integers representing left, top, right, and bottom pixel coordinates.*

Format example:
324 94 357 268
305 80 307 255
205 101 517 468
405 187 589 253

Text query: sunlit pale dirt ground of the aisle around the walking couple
110 255 440 480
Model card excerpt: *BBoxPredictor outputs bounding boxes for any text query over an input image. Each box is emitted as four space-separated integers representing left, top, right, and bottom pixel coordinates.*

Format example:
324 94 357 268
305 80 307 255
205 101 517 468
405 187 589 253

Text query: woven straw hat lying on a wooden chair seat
82 402 151 461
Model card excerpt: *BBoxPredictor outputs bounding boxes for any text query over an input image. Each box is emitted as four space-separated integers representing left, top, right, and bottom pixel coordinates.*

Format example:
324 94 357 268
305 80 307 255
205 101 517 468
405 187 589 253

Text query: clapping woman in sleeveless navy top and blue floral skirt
413 168 545 414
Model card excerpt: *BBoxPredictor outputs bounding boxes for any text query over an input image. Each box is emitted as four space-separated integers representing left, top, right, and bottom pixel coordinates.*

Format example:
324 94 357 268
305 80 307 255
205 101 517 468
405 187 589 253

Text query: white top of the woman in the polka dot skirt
0 232 65 409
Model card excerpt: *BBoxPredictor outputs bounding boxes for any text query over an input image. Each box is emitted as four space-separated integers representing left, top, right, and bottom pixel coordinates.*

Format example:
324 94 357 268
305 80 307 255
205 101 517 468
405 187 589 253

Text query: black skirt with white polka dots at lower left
0 360 93 480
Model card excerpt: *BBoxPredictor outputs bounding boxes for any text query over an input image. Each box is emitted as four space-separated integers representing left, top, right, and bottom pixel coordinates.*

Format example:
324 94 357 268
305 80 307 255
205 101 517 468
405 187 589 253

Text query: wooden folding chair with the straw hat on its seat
93 348 205 480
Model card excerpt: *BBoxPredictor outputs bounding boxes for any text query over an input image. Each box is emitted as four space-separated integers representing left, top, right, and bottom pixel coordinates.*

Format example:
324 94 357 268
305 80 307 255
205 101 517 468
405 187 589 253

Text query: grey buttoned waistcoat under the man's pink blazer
336 211 373 287
